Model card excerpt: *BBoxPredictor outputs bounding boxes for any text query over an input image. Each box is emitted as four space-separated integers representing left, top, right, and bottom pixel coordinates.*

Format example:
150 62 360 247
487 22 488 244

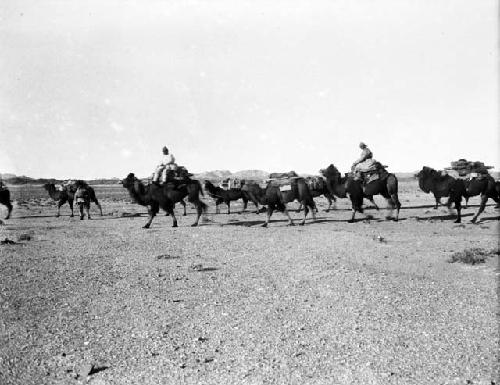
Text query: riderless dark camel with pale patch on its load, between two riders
242 178 316 227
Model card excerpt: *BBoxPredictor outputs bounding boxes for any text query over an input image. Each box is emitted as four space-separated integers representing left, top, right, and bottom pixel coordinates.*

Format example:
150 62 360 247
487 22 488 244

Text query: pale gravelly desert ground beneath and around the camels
0 180 500 385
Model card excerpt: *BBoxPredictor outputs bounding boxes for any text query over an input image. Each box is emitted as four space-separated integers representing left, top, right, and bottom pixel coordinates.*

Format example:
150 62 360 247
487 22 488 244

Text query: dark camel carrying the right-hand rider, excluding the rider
320 164 401 223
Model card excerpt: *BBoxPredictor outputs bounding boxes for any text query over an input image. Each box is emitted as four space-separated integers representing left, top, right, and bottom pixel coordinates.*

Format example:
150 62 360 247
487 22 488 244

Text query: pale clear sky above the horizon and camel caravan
0 0 500 179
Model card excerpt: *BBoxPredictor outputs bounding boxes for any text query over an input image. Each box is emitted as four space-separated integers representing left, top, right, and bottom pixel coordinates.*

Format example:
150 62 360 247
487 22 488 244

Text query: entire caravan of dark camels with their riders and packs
0 143 500 228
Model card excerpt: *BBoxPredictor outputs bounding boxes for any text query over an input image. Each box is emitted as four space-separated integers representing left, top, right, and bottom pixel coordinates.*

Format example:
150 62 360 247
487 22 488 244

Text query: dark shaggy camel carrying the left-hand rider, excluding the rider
122 173 207 229
